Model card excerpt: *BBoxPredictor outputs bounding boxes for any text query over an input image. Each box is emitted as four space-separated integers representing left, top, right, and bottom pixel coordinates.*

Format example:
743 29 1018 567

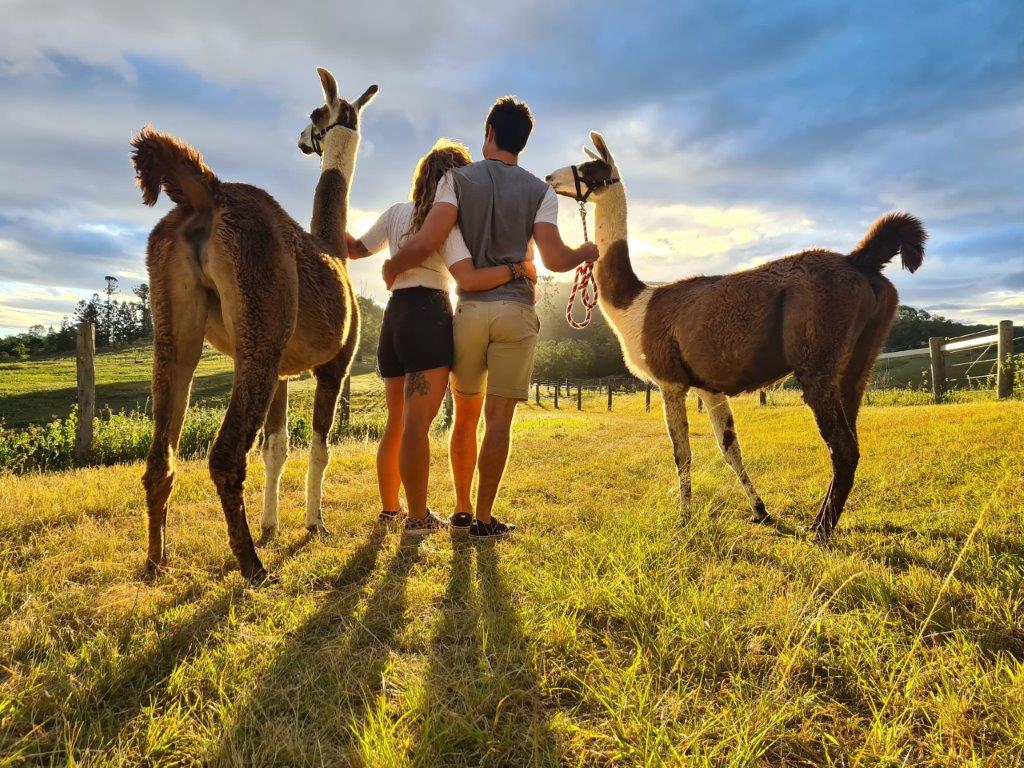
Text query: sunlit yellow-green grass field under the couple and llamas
0 394 1024 767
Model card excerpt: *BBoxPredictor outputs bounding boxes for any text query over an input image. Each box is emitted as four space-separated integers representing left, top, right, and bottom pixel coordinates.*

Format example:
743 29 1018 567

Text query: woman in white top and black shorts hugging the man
348 139 537 536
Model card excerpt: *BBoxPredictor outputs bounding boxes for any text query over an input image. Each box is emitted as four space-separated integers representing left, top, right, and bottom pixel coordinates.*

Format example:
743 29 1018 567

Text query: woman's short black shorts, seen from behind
377 288 455 379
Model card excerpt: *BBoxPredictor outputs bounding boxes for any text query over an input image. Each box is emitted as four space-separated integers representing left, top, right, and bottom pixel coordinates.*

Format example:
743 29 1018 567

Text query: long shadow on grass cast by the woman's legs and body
211 525 422 765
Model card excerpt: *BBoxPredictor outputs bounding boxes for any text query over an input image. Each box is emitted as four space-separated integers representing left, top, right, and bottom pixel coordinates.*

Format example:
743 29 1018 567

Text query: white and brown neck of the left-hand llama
309 126 359 258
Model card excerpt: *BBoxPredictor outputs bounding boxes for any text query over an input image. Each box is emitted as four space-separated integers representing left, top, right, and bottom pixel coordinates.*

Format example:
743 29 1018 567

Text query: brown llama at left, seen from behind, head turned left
131 68 378 582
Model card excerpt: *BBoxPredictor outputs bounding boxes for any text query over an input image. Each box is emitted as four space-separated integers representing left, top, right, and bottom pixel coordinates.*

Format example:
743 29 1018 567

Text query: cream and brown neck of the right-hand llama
594 183 646 309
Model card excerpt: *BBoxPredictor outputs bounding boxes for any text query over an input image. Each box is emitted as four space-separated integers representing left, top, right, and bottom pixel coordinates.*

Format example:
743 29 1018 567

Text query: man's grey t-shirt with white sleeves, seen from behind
434 160 558 305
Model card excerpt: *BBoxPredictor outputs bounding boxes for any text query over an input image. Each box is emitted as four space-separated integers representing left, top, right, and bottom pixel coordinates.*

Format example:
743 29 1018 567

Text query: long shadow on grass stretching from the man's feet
412 538 562 766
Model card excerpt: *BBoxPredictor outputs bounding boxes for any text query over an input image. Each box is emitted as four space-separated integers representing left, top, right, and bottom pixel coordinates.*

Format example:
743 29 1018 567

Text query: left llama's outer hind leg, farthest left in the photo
142 274 207 573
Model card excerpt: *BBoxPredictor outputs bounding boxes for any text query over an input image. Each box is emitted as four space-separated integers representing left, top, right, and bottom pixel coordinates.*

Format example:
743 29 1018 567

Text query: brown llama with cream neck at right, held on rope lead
548 132 927 542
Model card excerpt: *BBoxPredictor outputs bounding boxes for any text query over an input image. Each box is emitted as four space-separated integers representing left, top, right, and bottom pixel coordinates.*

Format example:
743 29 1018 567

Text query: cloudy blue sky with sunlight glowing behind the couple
0 0 1024 334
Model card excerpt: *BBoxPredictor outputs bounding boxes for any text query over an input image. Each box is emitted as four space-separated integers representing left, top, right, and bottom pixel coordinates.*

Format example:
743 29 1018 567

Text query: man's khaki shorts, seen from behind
452 300 541 400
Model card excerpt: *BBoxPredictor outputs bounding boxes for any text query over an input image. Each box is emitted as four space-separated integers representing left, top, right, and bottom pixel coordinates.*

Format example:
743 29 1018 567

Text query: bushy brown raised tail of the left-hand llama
131 125 220 209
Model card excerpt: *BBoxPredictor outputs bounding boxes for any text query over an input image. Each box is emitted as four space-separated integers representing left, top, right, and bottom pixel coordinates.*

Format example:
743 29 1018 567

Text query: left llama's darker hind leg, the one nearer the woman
210 354 281 582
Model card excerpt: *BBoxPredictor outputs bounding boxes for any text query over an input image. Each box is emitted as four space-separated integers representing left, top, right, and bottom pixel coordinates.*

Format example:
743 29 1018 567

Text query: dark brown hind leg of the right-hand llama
801 381 860 542
